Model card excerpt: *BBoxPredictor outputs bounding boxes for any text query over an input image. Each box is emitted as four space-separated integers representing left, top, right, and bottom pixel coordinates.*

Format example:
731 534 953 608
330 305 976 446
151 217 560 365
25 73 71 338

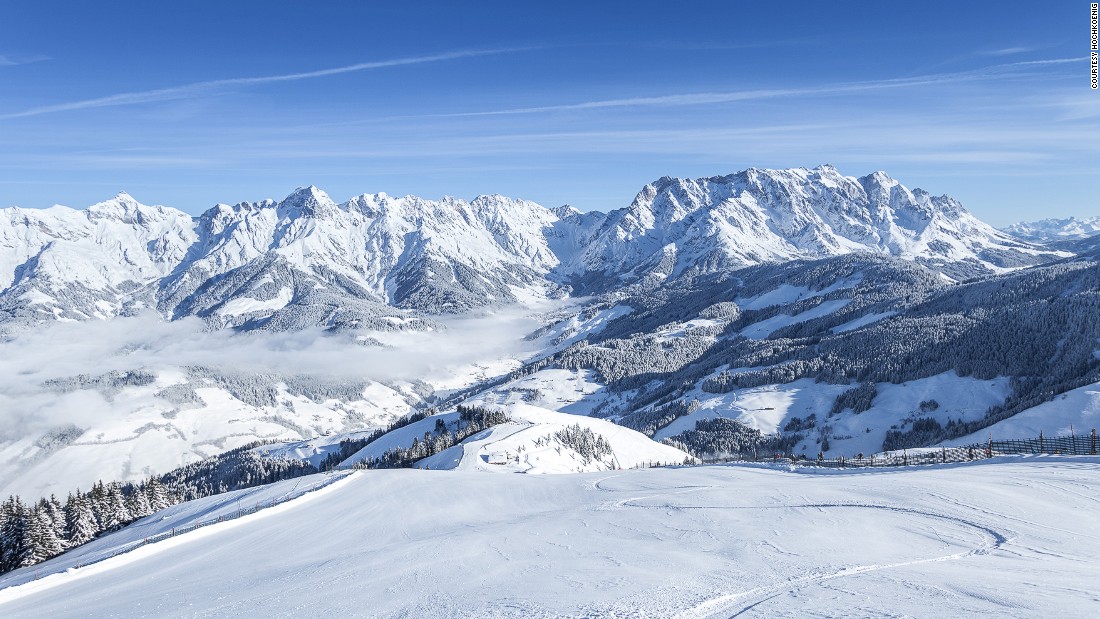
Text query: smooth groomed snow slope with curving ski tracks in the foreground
0 456 1100 618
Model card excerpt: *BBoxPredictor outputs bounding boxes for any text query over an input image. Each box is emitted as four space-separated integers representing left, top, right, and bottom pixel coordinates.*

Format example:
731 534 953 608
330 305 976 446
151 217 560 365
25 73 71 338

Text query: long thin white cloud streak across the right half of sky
427 57 1088 118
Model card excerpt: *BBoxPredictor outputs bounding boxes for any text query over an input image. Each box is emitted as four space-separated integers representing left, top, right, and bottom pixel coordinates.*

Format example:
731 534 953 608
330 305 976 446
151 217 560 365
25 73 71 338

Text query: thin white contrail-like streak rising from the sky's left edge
0 48 520 120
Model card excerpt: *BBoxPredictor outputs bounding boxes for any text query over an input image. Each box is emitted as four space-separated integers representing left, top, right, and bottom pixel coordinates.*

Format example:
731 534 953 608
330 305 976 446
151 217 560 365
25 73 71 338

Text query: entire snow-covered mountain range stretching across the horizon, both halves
0 166 1057 330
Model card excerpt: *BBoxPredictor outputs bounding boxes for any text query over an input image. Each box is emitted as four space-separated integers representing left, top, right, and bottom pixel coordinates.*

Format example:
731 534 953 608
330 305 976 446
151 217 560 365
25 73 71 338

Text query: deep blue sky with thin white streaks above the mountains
0 0 1100 224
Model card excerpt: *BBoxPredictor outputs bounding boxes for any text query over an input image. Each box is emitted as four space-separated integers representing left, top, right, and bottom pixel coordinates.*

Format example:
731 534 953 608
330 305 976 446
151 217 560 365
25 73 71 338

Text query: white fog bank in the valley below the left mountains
0 308 539 440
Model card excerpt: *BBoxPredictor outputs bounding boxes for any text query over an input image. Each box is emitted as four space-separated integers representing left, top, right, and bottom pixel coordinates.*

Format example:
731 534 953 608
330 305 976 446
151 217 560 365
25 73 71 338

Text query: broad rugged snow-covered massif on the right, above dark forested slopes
569 165 1052 286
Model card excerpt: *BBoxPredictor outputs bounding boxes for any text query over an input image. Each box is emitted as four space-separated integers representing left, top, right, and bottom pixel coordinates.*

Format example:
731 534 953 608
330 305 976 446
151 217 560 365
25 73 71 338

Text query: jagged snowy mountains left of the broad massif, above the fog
0 187 560 330
